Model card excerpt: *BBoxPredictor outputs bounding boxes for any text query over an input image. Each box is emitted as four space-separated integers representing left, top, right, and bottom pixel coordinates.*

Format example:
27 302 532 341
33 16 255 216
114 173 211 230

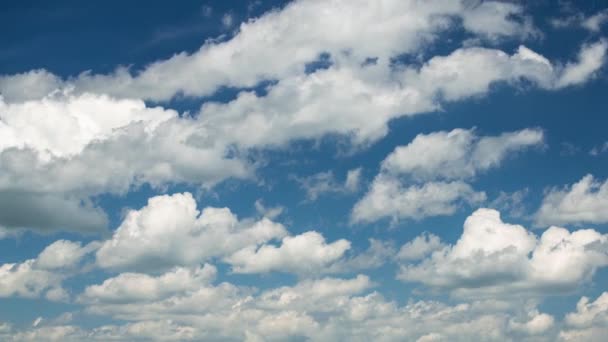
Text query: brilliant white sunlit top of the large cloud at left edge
0 94 177 161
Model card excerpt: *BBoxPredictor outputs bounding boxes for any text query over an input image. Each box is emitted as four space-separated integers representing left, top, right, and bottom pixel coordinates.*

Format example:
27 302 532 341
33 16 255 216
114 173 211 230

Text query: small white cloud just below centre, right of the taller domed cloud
224 231 350 274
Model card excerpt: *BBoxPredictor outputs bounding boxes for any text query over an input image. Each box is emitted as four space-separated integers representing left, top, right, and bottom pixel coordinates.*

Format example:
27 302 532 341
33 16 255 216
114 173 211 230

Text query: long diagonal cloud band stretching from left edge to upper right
0 10 605 235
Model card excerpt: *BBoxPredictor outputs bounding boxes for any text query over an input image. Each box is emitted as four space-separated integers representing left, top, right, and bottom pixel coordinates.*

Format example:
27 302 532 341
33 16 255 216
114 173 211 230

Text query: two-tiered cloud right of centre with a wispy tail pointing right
351 129 543 222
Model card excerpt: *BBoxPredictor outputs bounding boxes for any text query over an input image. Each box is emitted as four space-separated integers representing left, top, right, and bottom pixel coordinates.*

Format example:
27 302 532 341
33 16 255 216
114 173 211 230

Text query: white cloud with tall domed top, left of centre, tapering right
97 193 287 271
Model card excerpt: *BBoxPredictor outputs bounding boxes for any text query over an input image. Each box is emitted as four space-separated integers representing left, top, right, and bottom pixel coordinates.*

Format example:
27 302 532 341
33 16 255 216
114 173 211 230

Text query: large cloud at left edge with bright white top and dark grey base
0 94 250 232
